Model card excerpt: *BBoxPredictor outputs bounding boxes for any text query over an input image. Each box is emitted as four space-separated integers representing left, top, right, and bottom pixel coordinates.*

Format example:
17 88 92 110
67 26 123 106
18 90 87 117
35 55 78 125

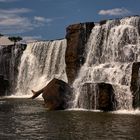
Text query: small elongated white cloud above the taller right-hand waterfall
98 8 131 16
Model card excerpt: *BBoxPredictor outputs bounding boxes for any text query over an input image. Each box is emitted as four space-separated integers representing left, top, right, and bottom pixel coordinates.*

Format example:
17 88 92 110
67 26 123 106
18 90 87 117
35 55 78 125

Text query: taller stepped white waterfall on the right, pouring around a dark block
73 16 140 109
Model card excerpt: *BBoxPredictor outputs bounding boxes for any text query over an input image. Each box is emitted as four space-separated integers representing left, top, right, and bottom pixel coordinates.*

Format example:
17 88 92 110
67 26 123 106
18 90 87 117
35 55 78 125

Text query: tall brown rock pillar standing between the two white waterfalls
65 22 94 84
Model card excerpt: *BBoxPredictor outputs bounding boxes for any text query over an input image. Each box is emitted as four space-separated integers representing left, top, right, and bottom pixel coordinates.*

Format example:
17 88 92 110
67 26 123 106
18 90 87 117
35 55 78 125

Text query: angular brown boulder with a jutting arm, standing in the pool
31 78 72 110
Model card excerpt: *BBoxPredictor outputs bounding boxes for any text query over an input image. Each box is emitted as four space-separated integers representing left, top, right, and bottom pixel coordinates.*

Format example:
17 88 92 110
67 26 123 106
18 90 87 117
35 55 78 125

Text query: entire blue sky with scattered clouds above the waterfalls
0 0 140 40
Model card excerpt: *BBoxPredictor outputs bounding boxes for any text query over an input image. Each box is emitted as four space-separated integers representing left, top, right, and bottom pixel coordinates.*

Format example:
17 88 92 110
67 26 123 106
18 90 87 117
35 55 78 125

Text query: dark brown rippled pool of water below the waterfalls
0 98 140 140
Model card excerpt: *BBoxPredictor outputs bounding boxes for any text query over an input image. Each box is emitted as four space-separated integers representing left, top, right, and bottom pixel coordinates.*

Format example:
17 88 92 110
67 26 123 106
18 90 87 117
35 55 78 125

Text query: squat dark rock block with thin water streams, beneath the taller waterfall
78 83 117 111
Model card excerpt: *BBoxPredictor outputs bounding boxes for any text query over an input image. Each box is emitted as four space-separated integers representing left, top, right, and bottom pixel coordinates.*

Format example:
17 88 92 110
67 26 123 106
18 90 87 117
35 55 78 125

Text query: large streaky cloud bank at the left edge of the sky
0 8 33 34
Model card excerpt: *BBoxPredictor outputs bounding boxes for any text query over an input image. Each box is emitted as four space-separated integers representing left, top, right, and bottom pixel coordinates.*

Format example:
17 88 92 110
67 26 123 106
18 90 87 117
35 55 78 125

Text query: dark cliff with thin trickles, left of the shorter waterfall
0 44 26 95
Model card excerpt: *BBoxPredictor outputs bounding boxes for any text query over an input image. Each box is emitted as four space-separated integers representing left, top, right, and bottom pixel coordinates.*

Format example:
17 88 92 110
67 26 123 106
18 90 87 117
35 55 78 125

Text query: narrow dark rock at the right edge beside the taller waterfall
130 62 140 108
